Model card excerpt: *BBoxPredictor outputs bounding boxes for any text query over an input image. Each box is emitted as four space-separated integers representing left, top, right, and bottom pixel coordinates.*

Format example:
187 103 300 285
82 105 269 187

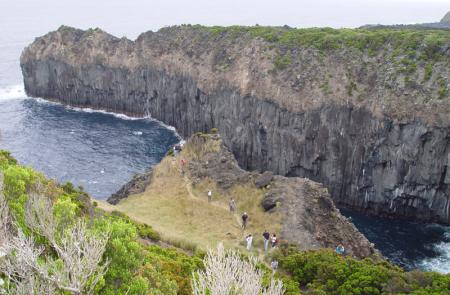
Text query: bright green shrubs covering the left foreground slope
0 151 202 294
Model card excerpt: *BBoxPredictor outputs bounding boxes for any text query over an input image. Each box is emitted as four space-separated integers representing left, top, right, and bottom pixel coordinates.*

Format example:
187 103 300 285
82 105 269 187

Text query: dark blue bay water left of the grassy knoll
0 92 180 199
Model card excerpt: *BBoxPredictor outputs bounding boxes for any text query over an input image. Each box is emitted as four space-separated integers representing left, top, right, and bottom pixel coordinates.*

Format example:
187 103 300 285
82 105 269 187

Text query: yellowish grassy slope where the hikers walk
99 150 281 252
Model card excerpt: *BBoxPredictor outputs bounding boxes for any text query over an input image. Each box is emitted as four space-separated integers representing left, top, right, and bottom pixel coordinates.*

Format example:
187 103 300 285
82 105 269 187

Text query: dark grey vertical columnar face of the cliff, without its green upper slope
21 29 450 223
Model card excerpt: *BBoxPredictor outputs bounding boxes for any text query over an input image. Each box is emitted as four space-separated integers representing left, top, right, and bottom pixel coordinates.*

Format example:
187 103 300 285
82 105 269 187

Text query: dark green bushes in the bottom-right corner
275 248 450 295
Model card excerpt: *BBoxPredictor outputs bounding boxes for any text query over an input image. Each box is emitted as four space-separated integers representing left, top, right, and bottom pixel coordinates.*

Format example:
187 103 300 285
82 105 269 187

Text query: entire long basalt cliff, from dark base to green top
21 26 450 224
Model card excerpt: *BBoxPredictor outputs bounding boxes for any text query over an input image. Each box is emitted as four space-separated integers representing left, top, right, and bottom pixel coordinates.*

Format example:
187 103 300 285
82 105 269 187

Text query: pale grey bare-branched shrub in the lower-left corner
0 176 109 294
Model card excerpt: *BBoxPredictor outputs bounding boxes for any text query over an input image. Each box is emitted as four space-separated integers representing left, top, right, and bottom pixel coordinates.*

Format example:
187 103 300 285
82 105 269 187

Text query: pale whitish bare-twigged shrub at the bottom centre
192 244 284 295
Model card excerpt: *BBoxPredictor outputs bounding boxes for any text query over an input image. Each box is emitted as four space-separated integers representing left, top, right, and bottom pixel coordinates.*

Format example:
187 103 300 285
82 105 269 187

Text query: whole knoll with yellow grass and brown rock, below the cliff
101 133 378 258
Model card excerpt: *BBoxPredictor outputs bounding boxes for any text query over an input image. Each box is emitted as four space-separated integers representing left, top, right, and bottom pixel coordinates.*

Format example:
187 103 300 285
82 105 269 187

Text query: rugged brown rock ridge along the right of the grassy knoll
181 134 379 258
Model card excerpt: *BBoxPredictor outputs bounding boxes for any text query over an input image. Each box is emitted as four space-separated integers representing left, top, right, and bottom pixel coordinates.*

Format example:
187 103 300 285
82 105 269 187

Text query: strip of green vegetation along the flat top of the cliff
177 25 450 61
